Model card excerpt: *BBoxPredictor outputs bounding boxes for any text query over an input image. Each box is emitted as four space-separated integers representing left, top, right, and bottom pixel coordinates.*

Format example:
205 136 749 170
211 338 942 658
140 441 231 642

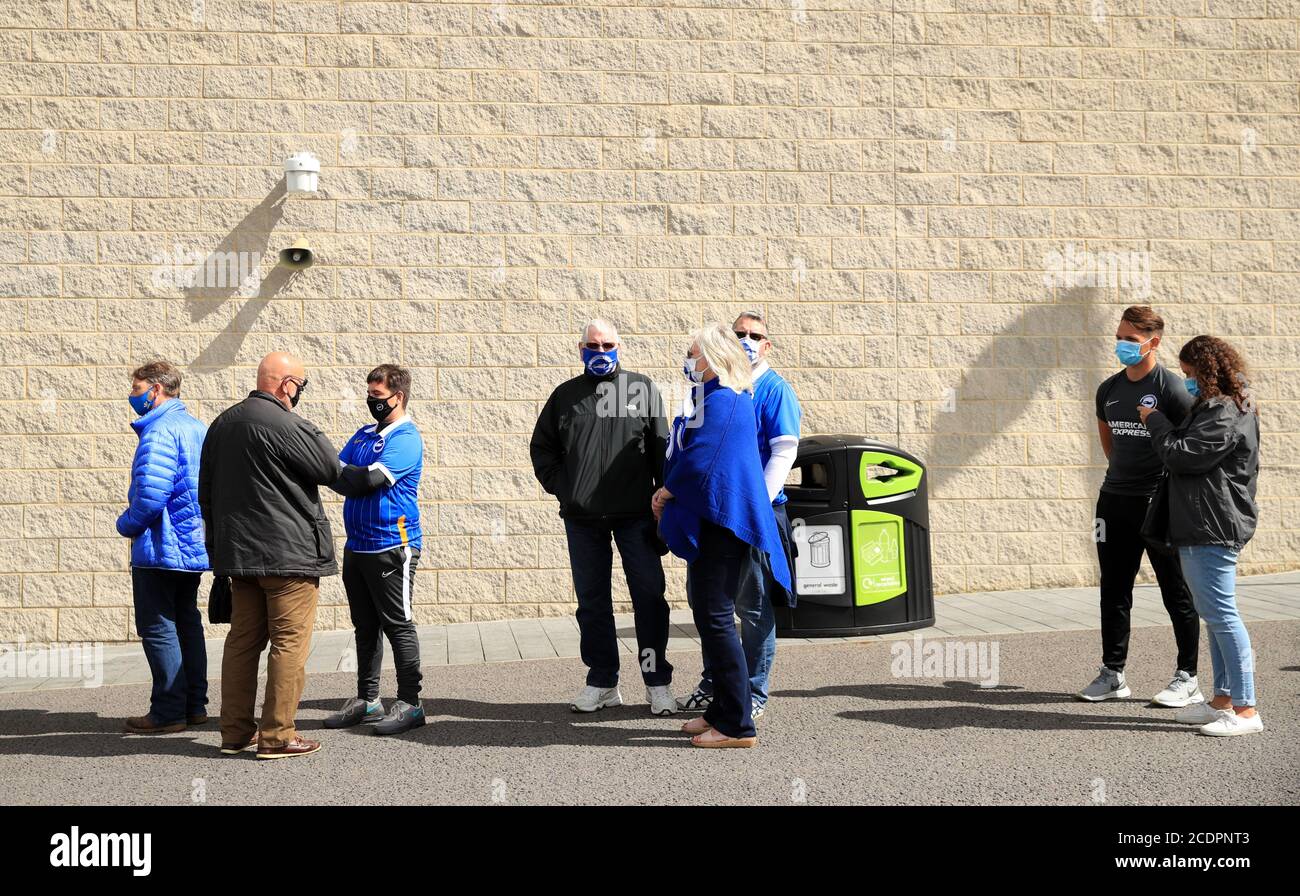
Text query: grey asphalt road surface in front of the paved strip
0 622 1300 805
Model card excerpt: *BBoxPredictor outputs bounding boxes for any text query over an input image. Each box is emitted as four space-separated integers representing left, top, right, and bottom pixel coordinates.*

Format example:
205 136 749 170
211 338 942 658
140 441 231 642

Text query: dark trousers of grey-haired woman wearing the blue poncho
686 521 758 737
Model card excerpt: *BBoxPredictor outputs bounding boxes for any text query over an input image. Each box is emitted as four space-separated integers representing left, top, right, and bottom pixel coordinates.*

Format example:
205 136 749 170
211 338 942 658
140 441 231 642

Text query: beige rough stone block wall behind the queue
0 0 1300 640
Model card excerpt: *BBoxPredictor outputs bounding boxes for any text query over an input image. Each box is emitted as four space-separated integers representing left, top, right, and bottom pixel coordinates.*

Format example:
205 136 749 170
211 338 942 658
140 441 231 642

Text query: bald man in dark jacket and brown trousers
199 351 339 759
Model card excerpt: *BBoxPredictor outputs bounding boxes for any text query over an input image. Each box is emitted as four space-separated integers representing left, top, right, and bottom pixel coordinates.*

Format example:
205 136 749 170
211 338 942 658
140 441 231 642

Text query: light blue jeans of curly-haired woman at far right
1178 545 1255 706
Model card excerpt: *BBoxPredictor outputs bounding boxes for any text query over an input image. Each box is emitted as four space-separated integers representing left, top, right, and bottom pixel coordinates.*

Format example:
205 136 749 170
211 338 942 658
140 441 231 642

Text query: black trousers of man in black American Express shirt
1096 492 1201 675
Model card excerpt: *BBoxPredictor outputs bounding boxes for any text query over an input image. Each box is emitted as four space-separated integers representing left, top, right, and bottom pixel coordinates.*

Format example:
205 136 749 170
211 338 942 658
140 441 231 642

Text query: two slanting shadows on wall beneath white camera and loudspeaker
183 179 298 371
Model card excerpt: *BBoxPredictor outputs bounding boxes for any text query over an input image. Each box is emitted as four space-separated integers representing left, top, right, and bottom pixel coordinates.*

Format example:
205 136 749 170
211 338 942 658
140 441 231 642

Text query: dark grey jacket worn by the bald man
199 391 339 577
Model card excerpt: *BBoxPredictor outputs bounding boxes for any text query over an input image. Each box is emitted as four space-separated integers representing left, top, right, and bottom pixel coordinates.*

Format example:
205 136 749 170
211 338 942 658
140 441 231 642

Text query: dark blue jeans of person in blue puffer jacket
131 567 208 724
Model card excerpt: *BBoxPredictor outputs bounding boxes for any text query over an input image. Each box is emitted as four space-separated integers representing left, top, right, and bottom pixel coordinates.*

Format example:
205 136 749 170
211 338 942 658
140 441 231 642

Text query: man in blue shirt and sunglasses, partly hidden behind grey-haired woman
677 311 802 720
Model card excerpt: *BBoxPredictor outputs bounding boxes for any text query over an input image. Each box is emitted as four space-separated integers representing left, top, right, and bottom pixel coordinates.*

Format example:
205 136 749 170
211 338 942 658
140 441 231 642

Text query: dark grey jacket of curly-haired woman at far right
1147 395 1260 550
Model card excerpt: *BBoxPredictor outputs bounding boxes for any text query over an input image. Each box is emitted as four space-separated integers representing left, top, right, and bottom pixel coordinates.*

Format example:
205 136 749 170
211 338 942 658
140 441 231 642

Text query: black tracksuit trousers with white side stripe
343 547 423 706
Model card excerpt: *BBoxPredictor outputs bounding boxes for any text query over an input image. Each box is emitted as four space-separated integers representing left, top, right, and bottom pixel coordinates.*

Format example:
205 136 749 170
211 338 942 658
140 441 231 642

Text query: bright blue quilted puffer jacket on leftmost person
117 398 208 572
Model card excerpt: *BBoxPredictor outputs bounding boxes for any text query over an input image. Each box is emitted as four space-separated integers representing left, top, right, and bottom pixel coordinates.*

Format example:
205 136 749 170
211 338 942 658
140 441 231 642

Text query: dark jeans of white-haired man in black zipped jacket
564 516 672 688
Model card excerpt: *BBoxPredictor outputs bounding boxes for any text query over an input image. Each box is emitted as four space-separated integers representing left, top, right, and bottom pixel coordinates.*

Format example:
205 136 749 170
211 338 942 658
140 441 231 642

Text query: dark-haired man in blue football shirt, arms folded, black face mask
325 364 425 735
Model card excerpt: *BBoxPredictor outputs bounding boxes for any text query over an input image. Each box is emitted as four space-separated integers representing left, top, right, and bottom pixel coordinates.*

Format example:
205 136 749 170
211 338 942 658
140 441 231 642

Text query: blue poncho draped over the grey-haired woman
659 378 790 592
